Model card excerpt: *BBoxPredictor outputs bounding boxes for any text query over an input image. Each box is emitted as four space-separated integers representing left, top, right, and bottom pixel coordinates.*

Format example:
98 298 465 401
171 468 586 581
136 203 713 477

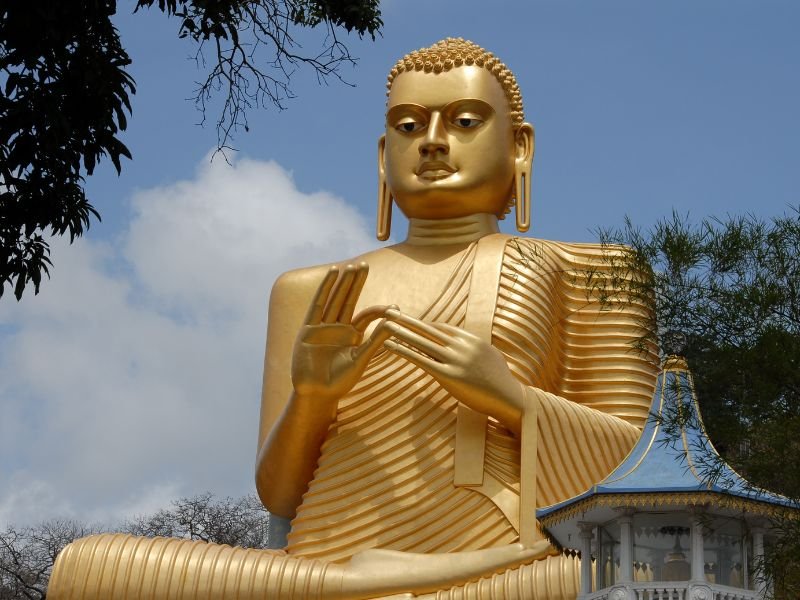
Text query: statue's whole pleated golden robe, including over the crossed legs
50 234 657 600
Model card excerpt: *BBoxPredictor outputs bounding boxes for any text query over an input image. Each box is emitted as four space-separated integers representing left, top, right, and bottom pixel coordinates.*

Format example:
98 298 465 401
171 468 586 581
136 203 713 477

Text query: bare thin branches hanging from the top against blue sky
136 0 383 151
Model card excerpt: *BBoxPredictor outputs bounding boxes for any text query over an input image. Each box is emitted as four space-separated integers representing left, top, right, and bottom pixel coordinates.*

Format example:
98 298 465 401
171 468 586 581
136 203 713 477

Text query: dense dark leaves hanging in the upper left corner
0 0 135 300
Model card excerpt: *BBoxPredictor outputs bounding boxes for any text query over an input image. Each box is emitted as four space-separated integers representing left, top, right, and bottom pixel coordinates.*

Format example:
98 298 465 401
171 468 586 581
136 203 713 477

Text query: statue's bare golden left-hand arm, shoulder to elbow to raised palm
256 263 390 517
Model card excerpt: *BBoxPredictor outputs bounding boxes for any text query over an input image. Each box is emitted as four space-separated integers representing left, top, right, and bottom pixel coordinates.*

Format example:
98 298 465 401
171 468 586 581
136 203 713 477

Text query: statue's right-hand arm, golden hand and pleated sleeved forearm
386 311 640 510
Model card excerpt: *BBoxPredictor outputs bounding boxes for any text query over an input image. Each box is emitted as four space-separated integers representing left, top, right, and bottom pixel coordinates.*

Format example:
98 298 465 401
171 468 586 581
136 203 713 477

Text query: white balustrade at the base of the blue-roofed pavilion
578 581 759 600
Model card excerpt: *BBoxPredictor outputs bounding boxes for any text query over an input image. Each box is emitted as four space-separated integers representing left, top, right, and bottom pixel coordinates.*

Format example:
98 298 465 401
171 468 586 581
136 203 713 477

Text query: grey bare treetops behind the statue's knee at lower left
0 493 269 600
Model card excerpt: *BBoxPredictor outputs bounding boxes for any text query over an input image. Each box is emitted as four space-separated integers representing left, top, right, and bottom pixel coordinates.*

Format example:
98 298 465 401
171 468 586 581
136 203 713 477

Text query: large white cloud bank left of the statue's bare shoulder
0 160 374 525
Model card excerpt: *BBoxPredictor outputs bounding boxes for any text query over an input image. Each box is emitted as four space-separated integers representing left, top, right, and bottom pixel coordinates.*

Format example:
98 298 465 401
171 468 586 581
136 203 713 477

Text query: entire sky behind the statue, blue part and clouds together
0 0 800 524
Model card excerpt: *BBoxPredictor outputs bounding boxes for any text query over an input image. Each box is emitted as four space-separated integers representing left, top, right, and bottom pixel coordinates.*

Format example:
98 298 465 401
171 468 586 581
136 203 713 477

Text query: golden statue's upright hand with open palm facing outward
292 263 391 409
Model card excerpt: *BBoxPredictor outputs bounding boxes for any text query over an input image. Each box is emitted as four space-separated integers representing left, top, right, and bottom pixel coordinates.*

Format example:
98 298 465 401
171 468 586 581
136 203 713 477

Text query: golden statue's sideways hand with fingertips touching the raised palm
384 309 525 433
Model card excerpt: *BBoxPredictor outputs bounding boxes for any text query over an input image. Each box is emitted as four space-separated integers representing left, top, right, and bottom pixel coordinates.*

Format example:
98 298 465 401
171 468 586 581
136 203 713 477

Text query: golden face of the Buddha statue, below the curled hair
379 66 515 219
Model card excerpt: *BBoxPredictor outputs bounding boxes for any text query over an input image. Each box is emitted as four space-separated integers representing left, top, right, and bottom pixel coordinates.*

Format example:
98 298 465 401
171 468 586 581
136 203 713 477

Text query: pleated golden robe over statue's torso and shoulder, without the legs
287 236 656 597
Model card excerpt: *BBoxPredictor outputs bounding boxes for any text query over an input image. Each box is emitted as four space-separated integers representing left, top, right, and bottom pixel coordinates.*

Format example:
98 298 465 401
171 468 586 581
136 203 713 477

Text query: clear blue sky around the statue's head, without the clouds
89 0 800 239
